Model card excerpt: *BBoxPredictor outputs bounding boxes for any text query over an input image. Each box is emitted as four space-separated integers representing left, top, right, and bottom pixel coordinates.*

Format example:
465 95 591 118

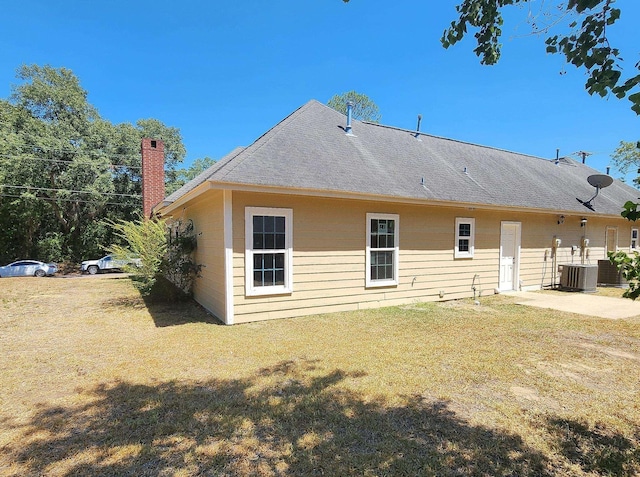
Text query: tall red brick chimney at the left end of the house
142 138 164 219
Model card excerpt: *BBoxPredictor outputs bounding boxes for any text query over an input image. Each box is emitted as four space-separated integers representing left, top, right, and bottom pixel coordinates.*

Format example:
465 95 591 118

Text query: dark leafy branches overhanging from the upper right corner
343 0 640 114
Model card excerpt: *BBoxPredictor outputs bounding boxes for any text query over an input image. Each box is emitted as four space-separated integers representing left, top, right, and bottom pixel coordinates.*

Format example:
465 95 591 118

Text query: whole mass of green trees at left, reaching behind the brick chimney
0 65 185 262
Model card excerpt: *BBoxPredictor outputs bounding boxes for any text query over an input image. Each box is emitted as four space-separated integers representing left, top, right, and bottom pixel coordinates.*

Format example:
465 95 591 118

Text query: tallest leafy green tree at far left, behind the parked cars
0 66 114 259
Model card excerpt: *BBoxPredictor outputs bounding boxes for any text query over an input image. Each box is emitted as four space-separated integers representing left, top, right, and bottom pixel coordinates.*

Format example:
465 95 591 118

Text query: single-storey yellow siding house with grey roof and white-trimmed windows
155 101 638 324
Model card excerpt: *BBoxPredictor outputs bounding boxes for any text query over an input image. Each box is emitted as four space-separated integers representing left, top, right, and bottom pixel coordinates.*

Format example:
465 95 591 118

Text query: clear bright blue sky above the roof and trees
0 0 640 179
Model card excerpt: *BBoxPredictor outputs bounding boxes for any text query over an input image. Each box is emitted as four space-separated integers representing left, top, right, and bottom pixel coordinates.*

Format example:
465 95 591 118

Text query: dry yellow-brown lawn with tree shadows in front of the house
0 277 640 476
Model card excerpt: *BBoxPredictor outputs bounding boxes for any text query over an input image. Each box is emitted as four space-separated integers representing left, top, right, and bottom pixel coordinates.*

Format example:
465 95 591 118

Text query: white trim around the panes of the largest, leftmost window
244 207 293 296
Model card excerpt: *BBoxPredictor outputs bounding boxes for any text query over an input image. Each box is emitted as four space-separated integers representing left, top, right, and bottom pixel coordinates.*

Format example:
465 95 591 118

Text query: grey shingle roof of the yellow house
167 100 639 216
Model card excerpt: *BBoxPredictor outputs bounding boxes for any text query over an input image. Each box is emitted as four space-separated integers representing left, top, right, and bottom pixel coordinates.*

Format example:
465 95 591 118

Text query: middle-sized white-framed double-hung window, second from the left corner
366 214 400 287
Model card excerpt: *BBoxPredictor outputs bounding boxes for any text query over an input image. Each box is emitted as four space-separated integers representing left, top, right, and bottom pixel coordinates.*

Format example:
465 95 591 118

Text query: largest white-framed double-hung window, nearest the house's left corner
245 207 293 296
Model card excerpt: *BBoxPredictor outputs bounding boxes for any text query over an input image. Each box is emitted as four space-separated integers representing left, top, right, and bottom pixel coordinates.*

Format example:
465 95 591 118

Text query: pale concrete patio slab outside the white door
507 292 640 320
